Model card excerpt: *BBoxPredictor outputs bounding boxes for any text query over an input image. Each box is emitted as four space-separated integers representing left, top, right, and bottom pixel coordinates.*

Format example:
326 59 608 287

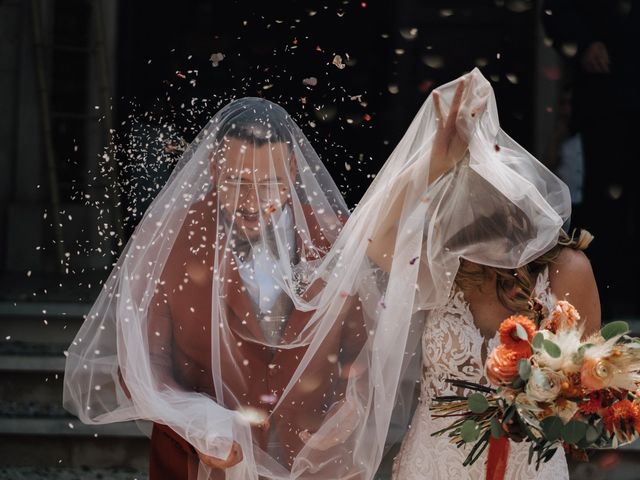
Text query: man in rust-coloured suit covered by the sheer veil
64 98 367 480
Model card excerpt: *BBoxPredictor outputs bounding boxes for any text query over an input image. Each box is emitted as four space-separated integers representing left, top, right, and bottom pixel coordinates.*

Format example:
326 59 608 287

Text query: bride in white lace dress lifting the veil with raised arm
367 71 600 480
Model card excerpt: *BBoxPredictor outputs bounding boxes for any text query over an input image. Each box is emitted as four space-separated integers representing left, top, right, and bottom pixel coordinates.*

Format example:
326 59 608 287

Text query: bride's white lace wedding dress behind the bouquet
393 269 569 480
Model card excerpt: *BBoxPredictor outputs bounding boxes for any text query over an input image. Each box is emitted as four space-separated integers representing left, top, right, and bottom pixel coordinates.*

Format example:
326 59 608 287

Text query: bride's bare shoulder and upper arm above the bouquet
549 248 601 338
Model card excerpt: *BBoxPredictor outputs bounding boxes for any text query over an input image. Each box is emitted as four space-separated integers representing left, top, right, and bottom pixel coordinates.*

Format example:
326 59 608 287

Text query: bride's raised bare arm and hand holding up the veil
367 80 468 272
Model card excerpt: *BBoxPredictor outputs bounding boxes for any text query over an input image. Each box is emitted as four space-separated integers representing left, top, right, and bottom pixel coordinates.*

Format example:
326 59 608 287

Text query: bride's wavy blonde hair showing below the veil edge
455 229 593 316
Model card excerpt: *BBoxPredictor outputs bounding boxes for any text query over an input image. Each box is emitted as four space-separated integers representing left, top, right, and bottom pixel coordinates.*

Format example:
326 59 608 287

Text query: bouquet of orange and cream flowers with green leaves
431 300 640 479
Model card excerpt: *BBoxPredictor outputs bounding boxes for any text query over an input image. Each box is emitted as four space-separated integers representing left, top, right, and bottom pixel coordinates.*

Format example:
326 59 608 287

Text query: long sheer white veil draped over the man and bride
64 70 569 480
